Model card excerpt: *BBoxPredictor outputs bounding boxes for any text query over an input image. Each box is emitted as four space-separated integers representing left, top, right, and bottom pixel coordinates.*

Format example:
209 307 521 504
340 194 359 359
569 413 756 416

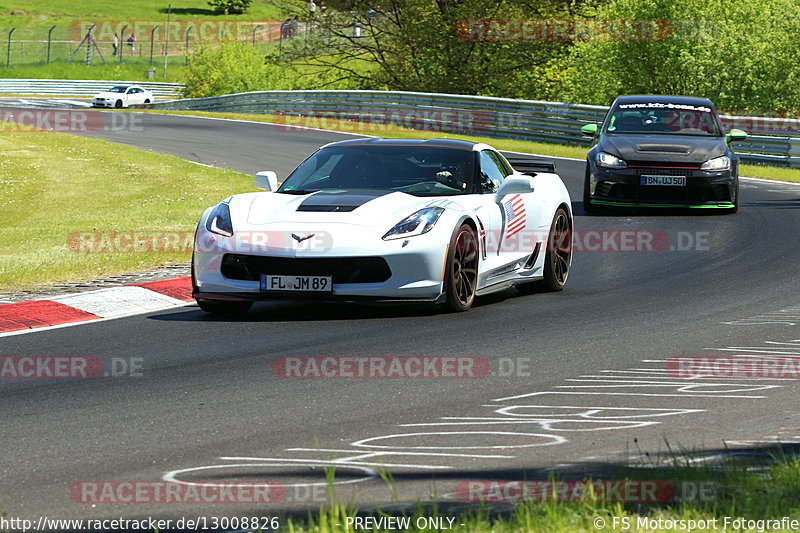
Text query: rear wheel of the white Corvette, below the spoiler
517 207 572 294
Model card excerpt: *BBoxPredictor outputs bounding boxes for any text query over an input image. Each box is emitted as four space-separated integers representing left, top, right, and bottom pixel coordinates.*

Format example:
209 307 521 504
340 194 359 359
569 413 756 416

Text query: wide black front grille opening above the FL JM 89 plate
222 254 392 284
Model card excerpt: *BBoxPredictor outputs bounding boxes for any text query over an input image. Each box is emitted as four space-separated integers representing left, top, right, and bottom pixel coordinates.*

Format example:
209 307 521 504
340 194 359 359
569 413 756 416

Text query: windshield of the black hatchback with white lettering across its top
606 102 722 137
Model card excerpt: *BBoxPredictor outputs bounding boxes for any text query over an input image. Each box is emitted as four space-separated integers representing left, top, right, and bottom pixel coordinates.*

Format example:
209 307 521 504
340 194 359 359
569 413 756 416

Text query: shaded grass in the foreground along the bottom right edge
285 455 800 533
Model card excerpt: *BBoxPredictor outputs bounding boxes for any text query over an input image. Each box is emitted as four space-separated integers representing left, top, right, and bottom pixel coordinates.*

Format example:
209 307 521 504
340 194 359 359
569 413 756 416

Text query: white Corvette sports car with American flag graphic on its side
192 138 572 313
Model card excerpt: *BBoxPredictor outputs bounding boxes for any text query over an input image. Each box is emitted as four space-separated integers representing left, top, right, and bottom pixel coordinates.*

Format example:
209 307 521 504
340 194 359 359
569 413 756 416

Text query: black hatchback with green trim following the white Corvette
581 96 747 213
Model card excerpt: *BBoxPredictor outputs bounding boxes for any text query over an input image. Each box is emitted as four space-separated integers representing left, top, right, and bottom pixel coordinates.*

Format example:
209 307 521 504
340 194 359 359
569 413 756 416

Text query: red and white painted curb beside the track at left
0 276 194 337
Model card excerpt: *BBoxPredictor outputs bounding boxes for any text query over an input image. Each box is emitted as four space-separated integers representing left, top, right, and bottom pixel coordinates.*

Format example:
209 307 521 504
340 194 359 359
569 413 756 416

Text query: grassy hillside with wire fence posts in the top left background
0 0 307 81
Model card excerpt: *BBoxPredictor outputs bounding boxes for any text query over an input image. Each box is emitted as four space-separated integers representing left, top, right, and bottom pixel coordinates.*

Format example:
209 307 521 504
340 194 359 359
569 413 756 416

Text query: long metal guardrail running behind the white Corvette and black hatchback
144 91 800 168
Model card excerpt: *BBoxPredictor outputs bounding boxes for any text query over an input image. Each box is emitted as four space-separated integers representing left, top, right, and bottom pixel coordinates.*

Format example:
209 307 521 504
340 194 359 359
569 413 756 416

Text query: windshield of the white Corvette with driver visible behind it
278 146 474 196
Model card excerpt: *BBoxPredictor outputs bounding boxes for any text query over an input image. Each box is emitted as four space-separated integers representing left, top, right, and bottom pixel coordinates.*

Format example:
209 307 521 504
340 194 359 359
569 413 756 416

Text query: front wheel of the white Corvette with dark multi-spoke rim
445 224 479 313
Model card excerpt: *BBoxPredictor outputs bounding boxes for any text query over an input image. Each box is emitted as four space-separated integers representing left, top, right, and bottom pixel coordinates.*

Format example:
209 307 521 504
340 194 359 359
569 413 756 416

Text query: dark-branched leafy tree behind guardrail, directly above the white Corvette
300 0 574 98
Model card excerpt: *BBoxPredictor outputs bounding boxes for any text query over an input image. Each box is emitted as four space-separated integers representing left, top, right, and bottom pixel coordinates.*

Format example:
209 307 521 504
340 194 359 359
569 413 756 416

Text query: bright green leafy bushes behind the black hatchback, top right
562 0 800 112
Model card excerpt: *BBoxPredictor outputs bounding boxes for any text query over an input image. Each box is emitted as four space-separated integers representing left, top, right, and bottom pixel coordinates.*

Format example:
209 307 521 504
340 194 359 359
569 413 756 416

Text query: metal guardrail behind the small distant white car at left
0 78 184 98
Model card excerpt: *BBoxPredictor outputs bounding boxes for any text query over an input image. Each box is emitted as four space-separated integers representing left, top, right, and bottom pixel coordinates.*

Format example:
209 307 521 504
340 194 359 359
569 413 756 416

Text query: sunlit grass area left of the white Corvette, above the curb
0 124 252 290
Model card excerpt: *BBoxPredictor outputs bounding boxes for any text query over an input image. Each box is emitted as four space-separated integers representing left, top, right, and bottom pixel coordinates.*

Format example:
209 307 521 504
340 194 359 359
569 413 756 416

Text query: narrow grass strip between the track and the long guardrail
144 109 800 183
